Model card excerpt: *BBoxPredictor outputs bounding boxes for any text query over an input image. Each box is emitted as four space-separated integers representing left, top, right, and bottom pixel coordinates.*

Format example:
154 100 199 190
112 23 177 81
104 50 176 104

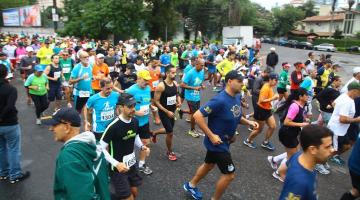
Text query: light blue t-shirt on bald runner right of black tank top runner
183 68 205 101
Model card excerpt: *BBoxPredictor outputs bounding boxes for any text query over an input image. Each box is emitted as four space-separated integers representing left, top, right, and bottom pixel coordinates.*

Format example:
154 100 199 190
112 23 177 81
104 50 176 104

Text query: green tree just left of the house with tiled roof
272 5 305 36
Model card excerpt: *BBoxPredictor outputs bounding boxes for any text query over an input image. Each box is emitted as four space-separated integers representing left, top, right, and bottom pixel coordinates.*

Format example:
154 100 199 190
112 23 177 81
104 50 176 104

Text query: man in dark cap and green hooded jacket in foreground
43 108 110 200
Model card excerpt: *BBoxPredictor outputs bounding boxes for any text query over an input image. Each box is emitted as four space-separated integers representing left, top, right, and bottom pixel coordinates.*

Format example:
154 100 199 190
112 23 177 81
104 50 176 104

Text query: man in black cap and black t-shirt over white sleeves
100 93 150 199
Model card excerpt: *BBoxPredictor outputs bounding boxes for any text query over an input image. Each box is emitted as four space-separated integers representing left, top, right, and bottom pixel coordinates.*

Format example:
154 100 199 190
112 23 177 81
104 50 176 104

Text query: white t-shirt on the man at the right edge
328 93 356 136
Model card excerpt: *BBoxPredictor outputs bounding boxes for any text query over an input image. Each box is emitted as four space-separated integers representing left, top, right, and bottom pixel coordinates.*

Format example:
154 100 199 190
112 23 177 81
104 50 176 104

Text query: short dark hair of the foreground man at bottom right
300 125 334 151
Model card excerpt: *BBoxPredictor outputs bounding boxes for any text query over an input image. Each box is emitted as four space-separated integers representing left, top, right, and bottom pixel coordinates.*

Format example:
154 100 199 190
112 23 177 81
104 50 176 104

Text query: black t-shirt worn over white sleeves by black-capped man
103 117 139 162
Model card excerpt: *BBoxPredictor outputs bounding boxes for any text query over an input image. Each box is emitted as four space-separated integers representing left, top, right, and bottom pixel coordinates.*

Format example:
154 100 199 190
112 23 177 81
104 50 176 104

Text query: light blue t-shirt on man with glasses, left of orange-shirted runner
70 63 92 97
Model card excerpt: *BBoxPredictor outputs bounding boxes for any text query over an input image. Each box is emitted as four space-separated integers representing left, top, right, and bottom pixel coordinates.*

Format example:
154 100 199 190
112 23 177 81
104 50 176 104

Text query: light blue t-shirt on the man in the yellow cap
125 84 151 126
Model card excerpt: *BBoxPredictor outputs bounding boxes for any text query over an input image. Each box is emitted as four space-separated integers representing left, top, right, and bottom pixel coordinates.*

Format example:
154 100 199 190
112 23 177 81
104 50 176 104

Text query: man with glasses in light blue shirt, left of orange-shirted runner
69 51 92 113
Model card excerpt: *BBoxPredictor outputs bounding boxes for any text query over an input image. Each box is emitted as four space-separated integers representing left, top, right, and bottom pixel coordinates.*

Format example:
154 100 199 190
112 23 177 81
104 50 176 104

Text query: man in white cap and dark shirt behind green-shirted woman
19 46 38 104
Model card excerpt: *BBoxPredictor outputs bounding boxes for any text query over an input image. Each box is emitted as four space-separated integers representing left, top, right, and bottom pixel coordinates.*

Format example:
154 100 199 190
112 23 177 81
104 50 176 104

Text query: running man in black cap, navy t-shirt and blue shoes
183 70 258 200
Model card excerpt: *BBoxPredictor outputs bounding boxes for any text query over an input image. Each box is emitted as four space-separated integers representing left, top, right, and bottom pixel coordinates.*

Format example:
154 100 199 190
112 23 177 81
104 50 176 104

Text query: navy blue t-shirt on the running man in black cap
200 90 242 152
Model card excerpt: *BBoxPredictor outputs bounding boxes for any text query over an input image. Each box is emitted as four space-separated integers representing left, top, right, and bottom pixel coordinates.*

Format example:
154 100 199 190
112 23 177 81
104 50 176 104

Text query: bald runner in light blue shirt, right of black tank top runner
181 59 205 138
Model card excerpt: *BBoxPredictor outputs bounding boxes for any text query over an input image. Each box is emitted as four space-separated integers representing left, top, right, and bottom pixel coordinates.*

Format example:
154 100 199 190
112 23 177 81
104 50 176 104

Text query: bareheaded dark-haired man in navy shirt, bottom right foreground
279 125 334 200
